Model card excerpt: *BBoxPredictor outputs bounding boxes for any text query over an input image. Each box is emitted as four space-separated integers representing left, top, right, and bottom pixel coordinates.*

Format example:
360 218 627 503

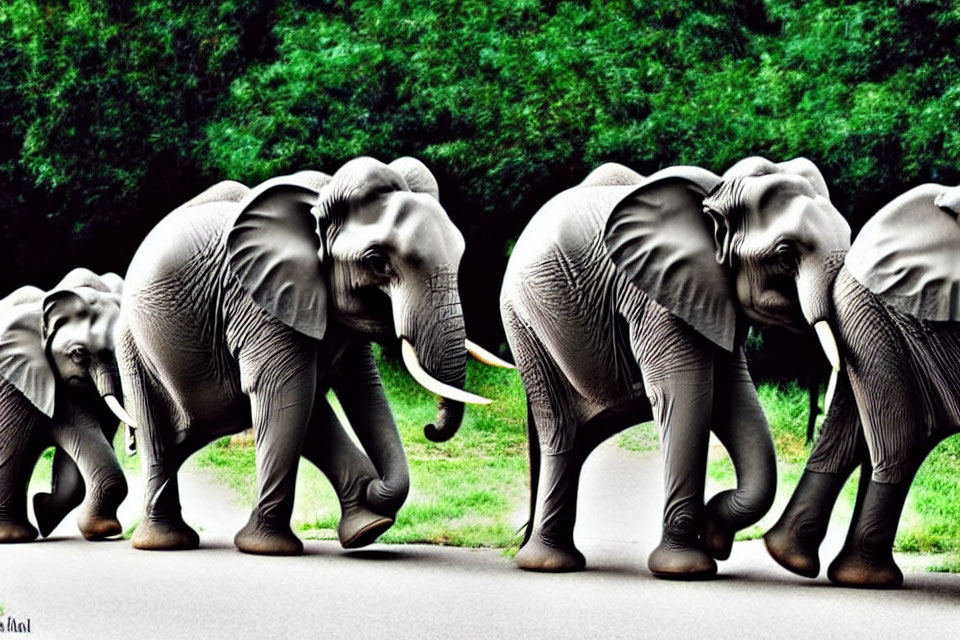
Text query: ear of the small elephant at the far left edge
0 298 56 417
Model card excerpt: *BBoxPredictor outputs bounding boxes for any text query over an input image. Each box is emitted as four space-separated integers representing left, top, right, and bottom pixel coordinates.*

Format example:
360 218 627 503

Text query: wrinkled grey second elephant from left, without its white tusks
120 158 466 555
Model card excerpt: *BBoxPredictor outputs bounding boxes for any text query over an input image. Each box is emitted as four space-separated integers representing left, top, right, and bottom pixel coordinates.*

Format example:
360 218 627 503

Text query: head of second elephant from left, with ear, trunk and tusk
227 158 489 440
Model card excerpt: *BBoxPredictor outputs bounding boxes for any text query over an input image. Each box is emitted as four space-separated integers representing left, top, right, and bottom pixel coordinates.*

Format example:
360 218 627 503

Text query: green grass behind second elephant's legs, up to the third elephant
195 354 528 547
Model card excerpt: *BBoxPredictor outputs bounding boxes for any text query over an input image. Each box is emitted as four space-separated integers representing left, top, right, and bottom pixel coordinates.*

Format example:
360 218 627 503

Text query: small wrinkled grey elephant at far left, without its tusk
0 269 127 543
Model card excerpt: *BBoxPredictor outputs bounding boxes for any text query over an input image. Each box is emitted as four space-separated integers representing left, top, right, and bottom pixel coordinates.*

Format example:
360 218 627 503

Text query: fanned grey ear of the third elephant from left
605 167 737 351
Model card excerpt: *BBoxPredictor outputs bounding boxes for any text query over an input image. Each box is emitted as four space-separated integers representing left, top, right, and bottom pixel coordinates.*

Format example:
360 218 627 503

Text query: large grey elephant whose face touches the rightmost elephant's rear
500 158 850 579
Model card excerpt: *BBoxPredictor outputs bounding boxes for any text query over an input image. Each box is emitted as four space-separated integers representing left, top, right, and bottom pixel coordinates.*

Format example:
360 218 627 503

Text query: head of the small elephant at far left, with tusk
0 269 133 426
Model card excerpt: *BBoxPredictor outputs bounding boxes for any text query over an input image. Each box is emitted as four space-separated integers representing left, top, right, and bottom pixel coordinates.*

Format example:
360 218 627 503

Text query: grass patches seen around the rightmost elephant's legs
708 383 960 572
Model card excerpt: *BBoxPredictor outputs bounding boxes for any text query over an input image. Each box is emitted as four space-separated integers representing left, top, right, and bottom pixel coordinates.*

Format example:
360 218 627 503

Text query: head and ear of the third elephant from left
605 158 850 370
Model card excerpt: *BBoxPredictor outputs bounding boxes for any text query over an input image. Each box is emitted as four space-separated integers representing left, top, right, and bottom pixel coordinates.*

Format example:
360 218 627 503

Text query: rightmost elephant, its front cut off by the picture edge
764 184 960 588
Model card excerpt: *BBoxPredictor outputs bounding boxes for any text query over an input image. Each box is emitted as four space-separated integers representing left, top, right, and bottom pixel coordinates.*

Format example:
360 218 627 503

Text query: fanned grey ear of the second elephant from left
227 175 327 340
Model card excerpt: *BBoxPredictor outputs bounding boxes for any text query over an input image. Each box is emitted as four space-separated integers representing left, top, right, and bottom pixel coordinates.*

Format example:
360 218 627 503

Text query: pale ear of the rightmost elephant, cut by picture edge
846 184 960 322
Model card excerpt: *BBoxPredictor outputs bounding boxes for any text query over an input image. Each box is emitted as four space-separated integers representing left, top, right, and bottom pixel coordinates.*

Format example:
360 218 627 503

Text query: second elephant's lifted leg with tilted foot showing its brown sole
303 398 393 549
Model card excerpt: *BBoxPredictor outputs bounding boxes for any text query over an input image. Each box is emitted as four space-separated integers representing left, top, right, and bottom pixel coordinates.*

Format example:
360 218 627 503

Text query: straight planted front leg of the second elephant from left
233 363 317 555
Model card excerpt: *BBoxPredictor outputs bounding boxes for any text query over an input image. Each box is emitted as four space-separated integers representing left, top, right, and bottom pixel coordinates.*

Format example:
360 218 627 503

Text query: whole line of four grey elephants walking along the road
0 157 960 587
